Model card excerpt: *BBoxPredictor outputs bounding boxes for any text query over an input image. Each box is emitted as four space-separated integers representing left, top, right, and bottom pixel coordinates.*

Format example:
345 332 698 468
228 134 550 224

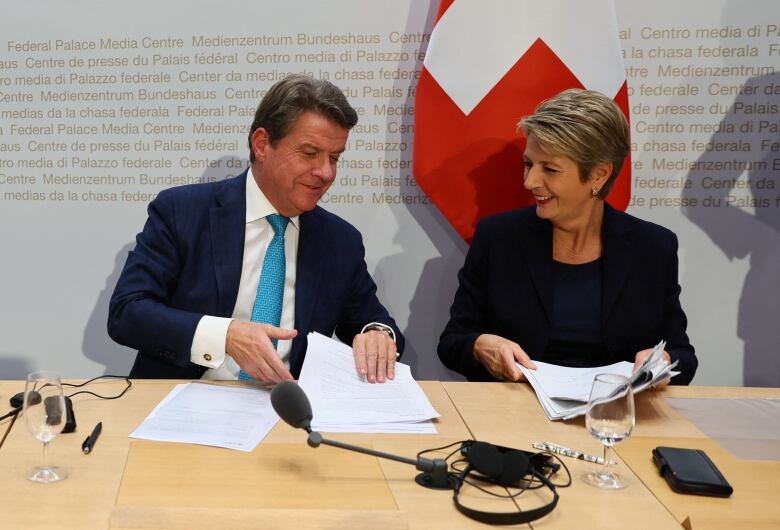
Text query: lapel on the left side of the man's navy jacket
209 172 247 317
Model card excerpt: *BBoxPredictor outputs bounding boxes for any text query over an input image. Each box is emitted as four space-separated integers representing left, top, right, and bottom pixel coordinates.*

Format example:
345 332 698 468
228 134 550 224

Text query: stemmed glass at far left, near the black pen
23 371 68 484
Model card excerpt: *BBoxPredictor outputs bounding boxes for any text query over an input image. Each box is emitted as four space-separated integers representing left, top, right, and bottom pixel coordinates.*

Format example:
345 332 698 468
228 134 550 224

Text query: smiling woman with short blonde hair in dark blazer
438 89 698 384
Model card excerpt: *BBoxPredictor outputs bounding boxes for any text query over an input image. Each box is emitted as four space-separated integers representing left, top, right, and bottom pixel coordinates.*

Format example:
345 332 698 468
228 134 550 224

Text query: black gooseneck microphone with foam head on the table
271 381 456 489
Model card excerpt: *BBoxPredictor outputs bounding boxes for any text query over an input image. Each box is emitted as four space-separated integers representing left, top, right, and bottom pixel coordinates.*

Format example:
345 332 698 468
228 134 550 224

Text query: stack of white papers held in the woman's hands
517 341 679 420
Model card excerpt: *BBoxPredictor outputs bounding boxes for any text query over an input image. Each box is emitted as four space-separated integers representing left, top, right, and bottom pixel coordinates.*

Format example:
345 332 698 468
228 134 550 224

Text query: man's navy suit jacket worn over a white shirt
108 172 404 379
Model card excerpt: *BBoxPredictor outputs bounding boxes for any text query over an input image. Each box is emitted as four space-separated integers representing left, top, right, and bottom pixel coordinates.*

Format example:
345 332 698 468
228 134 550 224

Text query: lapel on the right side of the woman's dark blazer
601 204 633 324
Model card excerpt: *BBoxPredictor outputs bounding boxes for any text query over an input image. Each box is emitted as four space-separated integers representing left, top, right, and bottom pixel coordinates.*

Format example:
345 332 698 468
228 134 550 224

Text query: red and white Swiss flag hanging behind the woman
413 0 631 242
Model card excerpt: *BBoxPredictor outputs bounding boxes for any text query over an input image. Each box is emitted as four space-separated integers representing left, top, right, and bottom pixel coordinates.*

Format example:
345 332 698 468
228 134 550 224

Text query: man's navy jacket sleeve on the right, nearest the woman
335 230 405 354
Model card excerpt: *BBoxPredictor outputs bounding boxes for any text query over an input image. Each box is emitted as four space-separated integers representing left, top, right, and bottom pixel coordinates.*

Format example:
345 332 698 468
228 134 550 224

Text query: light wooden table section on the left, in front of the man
0 380 516 530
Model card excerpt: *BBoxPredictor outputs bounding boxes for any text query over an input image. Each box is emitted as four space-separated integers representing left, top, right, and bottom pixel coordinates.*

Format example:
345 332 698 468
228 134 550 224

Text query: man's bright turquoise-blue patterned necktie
238 214 290 380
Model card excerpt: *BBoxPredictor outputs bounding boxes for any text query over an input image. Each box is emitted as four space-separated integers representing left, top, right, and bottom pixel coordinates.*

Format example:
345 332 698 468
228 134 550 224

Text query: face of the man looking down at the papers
252 112 349 217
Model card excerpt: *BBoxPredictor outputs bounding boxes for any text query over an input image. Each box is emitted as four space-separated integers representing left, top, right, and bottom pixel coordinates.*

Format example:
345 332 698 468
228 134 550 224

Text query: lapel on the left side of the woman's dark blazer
520 217 553 322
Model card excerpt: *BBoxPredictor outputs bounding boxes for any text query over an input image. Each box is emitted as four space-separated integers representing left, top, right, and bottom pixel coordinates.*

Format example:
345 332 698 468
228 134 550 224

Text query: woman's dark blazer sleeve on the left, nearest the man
437 220 495 381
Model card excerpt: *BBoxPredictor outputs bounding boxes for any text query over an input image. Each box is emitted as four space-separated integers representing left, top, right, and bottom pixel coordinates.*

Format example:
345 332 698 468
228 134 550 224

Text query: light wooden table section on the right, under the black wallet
443 382 780 530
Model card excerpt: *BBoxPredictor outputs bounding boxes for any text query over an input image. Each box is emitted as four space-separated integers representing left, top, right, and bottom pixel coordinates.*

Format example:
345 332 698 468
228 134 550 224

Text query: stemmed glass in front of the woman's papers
583 374 636 489
